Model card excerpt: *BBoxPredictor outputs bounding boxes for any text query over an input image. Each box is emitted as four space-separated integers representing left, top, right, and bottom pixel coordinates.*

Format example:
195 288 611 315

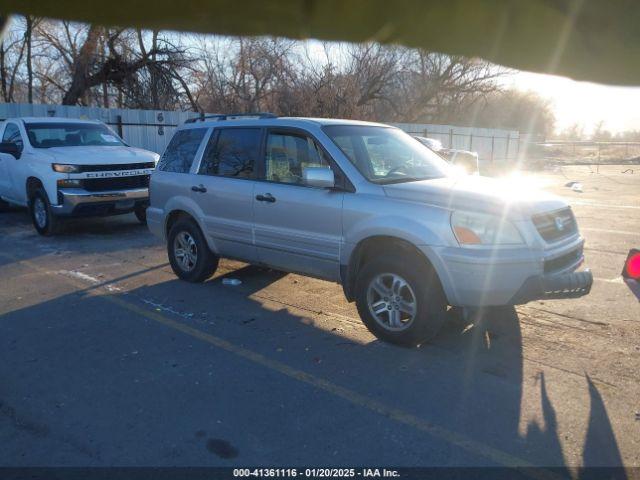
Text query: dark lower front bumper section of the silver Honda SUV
509 270 593 305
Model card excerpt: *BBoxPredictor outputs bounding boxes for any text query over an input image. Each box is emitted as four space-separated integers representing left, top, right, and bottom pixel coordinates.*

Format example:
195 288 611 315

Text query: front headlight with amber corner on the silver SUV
451 211 524 245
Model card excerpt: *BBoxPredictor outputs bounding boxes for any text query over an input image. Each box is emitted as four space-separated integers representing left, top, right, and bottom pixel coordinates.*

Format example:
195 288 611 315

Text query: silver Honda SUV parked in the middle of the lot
147 114 592 345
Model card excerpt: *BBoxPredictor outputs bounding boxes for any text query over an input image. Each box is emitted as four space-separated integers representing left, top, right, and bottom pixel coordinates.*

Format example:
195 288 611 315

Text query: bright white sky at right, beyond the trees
504 72 640 133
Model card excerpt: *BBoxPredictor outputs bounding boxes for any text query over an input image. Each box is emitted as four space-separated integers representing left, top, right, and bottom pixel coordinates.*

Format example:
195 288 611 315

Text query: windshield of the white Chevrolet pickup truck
25 123 124 148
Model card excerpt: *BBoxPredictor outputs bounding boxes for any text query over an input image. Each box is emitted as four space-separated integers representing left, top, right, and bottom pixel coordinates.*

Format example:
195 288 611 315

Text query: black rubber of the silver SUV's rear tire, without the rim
167 218 220 283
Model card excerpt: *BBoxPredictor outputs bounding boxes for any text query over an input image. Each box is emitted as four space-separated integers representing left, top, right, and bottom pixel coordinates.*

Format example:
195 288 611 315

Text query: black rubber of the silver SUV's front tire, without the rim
355 253 447 347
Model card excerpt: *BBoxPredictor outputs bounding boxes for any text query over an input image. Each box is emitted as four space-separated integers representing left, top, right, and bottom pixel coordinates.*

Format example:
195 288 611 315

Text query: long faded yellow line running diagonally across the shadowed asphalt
6 253 560 479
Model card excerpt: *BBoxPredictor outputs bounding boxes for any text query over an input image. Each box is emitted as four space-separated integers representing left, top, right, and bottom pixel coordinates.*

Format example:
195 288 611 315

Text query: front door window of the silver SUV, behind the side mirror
265 132 331 185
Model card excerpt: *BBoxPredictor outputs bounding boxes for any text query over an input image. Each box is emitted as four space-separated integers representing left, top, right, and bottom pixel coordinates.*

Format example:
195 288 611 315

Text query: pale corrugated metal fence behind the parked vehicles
0 103 520 162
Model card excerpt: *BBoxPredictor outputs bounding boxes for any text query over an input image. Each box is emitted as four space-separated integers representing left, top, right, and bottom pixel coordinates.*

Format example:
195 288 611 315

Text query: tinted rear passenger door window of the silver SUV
199 128 262 178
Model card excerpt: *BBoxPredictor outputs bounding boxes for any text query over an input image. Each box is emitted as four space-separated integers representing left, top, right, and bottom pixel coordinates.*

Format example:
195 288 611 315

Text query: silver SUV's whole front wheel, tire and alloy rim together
355 254 447 346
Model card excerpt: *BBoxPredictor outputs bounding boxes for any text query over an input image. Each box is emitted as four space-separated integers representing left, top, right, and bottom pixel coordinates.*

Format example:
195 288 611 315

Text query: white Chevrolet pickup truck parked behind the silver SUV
0 117 159 235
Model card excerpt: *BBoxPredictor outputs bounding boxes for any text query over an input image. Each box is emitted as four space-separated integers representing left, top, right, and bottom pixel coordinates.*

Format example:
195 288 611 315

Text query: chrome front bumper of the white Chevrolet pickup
52 188 149 217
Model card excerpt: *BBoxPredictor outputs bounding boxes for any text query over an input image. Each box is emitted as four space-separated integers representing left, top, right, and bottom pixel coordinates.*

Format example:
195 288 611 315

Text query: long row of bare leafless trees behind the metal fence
0 18 524 129
